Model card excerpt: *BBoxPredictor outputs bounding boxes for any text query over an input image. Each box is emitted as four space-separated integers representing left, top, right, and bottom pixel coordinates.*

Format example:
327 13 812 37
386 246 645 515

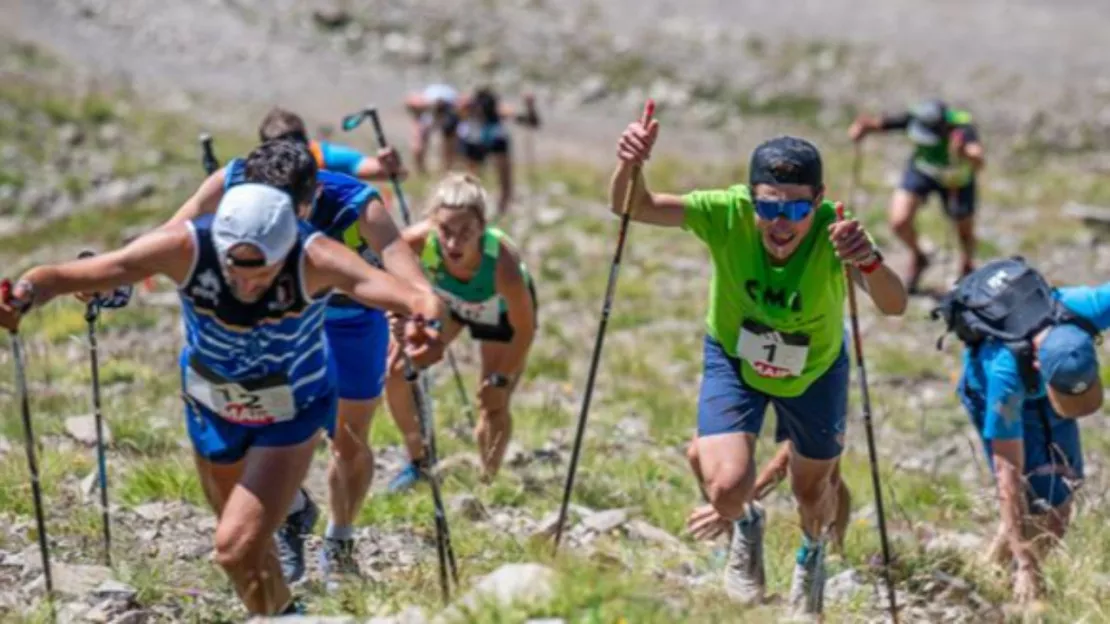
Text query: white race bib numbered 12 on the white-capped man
185 362 296 425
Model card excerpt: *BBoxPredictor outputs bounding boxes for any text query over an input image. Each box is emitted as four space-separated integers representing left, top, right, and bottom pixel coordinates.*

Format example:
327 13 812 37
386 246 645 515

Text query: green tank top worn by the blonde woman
421 228 532 326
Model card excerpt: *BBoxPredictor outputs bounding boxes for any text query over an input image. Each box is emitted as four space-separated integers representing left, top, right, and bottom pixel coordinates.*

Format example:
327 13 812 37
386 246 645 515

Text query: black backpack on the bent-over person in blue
929 255 1099 392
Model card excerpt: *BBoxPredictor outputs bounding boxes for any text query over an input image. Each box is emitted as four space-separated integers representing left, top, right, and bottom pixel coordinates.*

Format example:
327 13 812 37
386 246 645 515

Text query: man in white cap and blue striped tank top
0 177 442 615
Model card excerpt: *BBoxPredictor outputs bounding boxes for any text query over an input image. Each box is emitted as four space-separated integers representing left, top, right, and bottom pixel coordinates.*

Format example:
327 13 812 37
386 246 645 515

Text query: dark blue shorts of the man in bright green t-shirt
697 335 849 460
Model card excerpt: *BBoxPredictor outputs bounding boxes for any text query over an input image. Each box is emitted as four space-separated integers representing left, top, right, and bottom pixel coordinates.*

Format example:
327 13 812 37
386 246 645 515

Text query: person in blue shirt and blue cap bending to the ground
945 264 1110 602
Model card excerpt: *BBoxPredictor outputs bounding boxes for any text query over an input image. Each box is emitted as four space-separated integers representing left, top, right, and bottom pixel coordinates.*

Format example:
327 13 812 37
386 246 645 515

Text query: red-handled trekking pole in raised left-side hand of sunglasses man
554 100 655 551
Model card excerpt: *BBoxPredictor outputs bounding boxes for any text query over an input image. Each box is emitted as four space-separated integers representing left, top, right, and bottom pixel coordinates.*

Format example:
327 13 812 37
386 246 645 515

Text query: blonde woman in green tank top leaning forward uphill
385 173 537 481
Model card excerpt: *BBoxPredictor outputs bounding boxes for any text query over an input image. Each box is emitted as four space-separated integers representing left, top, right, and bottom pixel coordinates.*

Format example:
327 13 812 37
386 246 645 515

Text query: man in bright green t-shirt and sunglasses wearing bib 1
609 121 906 613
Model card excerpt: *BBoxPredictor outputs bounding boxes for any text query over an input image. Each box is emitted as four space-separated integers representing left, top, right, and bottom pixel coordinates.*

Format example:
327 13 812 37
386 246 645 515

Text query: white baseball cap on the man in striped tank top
212 183 297 265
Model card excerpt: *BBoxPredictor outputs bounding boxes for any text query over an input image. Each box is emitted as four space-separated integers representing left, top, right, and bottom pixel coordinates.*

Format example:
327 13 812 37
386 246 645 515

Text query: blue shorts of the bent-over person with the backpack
960 390 1083 513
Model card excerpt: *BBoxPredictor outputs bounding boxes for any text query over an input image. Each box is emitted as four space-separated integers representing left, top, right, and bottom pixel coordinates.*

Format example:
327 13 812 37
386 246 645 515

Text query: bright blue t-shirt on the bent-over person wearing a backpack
960 282 1110 440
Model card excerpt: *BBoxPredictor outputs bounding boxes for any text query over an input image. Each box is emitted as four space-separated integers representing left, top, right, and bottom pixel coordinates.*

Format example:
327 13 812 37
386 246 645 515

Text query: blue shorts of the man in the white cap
182 385 336 464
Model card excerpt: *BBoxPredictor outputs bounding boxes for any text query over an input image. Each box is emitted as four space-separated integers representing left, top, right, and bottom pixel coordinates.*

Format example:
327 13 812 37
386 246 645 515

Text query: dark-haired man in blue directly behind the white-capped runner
170 133 447 590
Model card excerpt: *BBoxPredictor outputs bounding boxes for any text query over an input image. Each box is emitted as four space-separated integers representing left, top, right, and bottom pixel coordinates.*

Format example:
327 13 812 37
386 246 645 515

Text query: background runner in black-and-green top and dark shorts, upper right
848 100 983 294
